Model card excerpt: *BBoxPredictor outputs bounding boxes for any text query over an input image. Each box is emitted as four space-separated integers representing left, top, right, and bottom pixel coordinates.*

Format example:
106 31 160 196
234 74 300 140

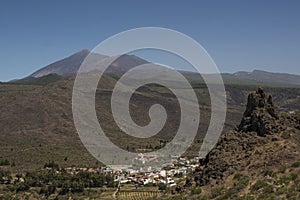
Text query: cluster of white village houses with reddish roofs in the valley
65 154 199 187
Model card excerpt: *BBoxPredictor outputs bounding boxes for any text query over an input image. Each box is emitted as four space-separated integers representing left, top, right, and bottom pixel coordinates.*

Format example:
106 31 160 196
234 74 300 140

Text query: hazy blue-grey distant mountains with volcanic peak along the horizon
20 49 300 85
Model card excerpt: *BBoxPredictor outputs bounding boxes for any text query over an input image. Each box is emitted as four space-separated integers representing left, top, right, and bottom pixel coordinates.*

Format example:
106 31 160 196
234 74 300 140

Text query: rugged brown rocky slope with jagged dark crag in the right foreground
186 88 300 199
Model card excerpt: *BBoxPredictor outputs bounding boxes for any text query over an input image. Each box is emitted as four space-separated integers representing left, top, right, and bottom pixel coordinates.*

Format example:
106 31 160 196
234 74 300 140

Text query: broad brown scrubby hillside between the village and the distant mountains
0 72 300 170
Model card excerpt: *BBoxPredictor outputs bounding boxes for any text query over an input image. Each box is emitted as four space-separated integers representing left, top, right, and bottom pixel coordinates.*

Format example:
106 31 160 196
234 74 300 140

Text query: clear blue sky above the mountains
0 0 300 81
